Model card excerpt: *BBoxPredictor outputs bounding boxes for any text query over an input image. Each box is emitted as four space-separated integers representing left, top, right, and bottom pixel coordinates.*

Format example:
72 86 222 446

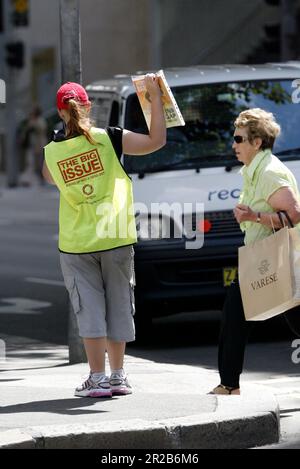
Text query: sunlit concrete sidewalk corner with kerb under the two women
0 337 280 449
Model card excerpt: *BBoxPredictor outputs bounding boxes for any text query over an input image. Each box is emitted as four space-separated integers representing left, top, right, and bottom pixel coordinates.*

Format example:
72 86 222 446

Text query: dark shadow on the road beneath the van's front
127 313 300 377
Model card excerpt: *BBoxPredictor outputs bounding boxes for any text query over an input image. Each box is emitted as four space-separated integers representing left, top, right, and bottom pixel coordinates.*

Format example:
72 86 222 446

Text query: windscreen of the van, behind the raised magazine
124 80 300 173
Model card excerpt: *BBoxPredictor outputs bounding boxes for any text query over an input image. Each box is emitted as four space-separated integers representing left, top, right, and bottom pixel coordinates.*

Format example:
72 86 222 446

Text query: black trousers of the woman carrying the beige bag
218 282 258 388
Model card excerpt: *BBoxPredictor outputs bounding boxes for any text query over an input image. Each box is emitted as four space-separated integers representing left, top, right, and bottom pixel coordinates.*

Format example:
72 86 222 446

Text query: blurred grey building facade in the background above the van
0 0 300 175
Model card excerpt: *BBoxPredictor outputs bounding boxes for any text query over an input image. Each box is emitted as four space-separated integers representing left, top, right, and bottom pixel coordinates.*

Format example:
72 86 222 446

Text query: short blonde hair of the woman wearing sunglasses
234 108 280 150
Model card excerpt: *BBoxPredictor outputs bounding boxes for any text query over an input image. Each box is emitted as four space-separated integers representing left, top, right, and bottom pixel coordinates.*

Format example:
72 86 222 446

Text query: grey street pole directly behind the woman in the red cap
60 0 87 364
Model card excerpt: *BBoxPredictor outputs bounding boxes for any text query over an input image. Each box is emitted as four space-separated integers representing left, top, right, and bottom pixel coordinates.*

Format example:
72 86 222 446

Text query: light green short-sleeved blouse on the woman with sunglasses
239 150 299 244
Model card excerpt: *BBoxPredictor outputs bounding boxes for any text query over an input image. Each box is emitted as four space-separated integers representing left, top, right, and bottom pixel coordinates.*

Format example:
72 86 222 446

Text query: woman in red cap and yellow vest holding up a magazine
43 74 166 397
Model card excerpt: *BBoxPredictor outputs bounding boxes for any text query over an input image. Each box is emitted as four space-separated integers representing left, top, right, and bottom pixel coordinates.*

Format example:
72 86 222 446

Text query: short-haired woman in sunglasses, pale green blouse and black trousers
210 108 300 395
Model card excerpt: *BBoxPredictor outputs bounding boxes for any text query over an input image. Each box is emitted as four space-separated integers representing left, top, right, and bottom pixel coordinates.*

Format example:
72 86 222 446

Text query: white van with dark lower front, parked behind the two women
87 63 300 332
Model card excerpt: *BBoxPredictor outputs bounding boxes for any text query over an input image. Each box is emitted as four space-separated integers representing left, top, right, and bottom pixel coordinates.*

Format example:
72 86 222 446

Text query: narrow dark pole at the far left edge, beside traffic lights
1 1 19 187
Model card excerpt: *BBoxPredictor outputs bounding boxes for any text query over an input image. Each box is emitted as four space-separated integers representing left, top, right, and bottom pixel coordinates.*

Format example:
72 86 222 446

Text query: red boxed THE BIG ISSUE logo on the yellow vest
57 149 104 183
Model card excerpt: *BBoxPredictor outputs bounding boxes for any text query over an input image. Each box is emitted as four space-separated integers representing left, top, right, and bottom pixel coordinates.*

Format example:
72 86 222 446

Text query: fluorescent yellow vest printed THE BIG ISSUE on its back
45 128 137 254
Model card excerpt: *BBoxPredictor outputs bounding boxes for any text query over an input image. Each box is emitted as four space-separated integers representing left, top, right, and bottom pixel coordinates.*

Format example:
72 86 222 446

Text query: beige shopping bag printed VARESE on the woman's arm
239 227 300 321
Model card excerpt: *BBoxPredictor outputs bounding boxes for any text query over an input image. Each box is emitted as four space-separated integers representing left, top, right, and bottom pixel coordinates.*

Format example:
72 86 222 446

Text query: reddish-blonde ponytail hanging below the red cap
66 99 97 145
